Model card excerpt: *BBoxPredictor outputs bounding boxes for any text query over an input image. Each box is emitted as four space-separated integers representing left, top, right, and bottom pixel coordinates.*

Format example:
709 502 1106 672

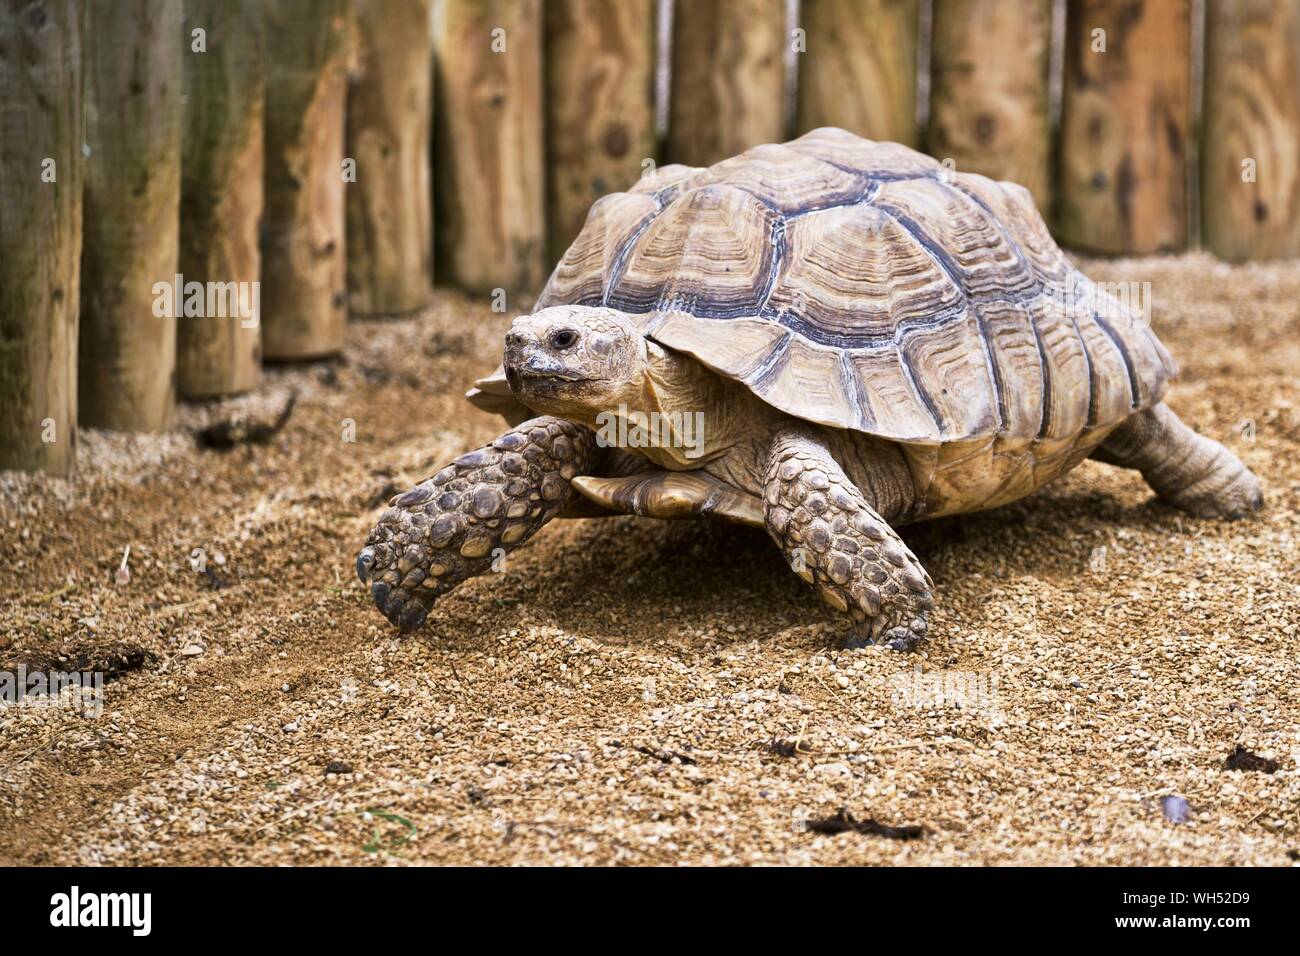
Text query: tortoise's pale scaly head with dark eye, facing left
502 306 649 419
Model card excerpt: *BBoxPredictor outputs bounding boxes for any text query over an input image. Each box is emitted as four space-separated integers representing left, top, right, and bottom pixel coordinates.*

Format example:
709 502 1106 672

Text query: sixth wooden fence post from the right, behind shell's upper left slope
546 0 655 263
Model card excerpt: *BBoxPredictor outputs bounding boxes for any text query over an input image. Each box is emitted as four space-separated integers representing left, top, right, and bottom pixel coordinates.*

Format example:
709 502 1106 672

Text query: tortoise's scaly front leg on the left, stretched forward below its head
356 416 602 632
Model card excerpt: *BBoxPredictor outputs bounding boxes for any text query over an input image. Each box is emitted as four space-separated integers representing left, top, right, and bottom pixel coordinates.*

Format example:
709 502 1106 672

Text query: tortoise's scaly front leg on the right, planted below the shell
763 427 935 650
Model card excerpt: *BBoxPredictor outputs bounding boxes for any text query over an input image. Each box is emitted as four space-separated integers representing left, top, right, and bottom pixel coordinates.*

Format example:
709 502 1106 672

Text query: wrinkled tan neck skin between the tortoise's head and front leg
585 341 779 478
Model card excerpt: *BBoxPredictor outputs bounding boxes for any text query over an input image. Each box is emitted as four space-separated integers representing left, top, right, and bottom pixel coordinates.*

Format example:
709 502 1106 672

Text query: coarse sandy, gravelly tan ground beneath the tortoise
0 255 1300 865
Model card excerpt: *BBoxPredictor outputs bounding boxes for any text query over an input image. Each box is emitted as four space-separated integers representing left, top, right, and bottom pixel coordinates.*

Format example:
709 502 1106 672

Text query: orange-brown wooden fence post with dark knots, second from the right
1057 0 1192 255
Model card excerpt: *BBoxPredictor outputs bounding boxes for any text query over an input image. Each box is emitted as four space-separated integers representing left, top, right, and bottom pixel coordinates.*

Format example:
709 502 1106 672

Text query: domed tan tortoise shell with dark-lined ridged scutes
527 129 1177 445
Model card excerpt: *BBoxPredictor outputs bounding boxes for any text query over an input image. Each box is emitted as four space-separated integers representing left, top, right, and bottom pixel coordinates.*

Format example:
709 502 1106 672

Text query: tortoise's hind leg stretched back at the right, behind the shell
1092 405 1264 519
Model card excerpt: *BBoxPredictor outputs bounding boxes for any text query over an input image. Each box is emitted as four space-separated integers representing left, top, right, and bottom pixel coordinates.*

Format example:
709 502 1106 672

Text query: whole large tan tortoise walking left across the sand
356 129 1264 649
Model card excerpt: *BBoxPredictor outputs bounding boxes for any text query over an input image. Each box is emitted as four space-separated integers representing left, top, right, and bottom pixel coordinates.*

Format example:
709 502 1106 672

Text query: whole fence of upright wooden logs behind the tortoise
0 0 1300 473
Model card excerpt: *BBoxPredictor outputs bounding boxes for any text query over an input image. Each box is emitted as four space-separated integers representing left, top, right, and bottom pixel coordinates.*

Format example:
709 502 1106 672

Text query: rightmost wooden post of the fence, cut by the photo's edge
1201 0 1300 261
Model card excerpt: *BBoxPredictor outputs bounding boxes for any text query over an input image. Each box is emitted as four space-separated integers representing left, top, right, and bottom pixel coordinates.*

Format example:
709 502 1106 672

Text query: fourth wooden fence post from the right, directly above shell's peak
794 0 919 146
